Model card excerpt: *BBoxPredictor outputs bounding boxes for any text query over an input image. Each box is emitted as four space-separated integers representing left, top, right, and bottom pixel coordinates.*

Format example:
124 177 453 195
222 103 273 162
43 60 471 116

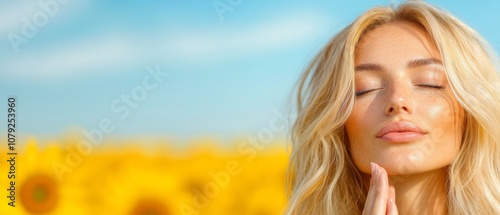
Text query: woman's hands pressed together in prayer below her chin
363 163 398 215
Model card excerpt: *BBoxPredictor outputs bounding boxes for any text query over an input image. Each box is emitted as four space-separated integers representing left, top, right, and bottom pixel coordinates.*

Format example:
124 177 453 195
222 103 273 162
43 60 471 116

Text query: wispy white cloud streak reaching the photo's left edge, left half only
4 36 137 80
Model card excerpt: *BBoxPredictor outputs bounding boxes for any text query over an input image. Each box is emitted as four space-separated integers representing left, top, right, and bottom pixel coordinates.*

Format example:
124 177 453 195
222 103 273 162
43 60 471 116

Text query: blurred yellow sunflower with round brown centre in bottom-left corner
0 137 87 215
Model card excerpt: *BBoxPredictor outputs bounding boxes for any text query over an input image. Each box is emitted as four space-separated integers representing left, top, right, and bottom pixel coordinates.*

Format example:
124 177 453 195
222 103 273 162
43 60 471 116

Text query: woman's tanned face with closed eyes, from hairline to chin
345 22 464 175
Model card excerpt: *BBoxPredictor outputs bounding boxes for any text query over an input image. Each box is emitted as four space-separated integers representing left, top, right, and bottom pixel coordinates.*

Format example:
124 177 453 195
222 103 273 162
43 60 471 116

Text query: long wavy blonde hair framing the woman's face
285 1 500 215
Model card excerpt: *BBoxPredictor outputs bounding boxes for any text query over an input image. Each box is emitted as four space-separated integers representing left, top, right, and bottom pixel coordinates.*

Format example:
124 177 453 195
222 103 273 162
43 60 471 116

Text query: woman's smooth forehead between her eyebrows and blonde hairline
355 21 441 65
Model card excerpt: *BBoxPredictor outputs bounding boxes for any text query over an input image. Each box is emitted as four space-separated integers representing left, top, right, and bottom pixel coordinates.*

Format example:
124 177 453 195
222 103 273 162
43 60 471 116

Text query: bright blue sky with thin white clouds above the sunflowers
0 0 500 142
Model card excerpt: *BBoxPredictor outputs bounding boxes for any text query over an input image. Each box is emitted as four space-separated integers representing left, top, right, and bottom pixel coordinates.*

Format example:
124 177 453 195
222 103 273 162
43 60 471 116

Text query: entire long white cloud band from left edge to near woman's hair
1 9 330 81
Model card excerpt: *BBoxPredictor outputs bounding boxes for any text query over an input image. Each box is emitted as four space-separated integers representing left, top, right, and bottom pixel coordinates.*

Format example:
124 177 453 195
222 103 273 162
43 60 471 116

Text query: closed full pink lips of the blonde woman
376 121 427 143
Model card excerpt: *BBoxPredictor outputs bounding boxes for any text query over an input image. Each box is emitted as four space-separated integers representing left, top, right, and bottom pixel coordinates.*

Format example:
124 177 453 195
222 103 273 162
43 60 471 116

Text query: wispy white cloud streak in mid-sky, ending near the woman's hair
164 13 330 61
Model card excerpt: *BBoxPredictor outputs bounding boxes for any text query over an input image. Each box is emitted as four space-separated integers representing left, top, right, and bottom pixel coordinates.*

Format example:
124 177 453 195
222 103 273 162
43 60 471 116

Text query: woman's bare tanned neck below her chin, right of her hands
389 168 448 215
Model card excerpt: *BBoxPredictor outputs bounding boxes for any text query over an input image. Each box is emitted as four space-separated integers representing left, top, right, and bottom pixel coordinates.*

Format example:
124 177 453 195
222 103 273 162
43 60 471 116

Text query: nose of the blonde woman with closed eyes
385 84 415 115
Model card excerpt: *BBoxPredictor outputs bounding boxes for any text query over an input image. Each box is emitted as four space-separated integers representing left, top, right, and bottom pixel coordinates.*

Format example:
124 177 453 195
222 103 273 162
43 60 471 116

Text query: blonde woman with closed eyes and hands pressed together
286 1 500 214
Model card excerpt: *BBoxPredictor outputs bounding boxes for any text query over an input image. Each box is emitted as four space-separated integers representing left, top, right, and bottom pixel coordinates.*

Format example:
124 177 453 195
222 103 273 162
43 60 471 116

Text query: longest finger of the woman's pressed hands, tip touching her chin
372 164 389 214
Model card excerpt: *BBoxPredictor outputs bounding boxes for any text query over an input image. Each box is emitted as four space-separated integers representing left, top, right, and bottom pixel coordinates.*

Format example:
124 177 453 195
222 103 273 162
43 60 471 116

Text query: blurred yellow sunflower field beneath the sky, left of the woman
0 137 288 215
